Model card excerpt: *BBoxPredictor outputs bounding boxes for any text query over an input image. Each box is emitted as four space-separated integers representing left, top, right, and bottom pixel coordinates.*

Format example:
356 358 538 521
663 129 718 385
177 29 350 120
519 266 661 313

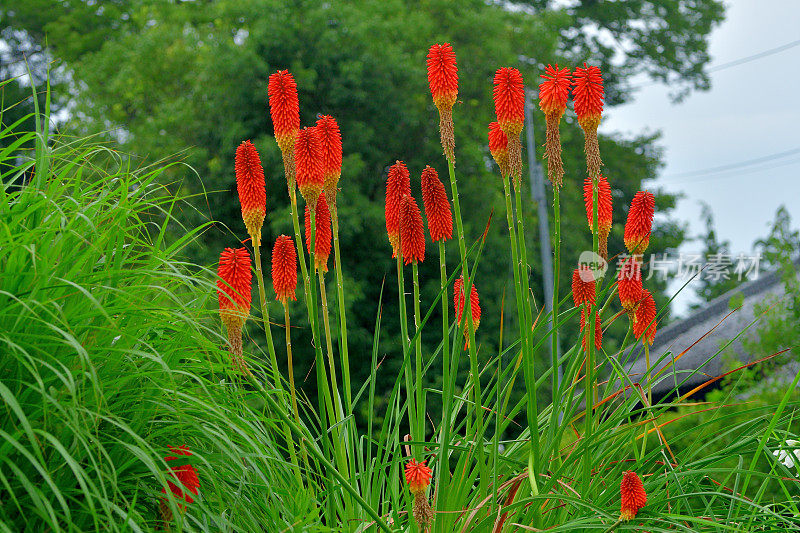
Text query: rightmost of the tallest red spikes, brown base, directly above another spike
572 63 604 179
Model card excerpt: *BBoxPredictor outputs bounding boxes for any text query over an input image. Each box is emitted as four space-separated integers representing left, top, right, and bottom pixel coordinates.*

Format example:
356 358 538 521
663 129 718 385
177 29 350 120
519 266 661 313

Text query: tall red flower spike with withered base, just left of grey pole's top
493 67 525 188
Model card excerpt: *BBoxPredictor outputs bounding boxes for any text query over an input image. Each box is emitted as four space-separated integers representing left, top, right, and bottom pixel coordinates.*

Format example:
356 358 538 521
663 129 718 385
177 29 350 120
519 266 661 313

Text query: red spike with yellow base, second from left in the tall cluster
234 141 267 246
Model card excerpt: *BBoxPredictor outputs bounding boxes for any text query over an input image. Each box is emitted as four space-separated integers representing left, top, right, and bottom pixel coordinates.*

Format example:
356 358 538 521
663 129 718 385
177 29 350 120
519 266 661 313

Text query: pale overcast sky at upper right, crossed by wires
601 0 800 312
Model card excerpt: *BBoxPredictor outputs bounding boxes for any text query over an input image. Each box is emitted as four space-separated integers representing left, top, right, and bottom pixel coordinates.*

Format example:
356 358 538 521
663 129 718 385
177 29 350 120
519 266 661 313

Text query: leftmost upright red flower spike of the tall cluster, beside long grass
217 248 253 327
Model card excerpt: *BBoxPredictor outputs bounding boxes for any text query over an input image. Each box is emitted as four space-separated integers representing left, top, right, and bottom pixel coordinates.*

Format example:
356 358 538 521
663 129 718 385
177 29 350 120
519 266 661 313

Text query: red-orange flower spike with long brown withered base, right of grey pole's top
539 63 572 188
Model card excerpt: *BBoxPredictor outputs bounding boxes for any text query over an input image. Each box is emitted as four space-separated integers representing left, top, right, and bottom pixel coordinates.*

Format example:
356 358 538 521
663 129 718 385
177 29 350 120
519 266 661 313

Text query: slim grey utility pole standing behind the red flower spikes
517 89 562 386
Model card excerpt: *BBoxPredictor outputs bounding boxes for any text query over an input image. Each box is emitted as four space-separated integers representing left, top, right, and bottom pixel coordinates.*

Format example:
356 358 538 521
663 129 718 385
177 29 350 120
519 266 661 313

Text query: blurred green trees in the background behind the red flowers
0 0 723 424
